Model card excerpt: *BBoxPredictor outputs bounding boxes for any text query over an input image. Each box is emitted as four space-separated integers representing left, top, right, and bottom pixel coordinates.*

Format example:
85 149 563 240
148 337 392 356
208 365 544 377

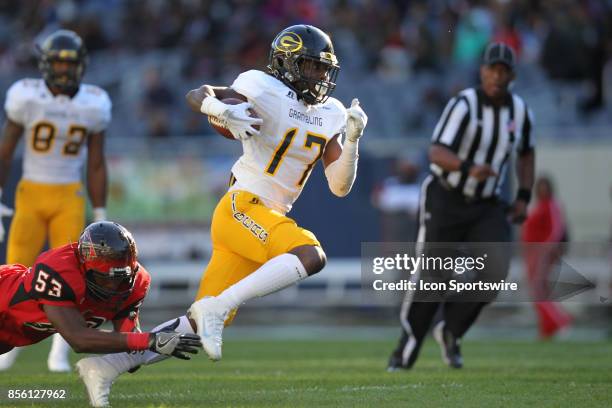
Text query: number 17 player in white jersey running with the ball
77 25 367 406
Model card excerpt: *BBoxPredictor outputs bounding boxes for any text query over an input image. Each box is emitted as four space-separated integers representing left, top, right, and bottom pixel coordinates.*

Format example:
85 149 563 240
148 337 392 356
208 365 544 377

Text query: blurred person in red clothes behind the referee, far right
522 176 572 339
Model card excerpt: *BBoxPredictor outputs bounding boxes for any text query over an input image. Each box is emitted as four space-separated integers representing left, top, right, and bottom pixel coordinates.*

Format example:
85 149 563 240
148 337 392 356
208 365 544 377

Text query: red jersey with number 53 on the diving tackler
0 244 151 347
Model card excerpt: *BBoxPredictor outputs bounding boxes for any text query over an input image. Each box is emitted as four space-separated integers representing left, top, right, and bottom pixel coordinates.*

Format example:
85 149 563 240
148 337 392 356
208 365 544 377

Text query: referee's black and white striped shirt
430 88 534 199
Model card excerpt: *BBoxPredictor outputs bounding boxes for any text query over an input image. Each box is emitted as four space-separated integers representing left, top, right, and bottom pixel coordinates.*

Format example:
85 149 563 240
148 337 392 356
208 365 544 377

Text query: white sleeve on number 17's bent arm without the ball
325 139 359 197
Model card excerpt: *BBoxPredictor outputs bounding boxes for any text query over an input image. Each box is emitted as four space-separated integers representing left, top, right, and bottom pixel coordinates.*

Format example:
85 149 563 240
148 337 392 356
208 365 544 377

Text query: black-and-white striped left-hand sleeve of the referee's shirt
431 96 470 153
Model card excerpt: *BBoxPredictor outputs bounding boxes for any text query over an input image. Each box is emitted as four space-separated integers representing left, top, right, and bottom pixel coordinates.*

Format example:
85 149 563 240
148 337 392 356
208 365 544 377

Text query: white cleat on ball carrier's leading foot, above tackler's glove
187 296 229 361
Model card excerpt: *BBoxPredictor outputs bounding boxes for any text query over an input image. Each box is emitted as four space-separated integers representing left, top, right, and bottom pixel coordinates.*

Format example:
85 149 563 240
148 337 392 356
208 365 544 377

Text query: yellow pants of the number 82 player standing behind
6 180 85 266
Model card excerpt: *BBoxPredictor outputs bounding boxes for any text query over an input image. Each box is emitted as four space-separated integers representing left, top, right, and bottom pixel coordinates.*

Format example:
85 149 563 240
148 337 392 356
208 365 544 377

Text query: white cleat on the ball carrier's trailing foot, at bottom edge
76 357 120 407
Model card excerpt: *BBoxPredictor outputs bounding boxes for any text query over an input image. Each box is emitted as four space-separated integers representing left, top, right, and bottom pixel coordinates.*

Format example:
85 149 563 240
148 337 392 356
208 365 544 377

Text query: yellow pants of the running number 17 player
196 191 320 322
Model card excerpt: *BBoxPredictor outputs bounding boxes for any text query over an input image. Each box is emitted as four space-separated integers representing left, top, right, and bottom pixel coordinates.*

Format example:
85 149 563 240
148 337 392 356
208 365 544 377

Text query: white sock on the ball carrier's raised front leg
217 254 308 310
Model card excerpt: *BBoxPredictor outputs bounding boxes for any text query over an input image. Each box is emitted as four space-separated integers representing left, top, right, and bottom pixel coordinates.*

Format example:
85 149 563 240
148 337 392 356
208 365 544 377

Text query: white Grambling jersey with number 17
231 70 346 214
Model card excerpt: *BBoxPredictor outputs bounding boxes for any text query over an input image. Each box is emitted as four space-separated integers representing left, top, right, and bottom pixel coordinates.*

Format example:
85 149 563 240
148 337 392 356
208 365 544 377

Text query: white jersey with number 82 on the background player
4 79 111 184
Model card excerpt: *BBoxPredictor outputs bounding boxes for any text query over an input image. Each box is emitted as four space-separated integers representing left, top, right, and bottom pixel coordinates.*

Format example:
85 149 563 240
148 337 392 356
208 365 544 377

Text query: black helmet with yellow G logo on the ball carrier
268 24 340 105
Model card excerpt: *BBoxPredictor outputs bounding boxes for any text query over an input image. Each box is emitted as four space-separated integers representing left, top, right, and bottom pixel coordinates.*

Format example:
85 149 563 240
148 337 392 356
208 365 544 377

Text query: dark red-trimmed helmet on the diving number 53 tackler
77 221 138 302
